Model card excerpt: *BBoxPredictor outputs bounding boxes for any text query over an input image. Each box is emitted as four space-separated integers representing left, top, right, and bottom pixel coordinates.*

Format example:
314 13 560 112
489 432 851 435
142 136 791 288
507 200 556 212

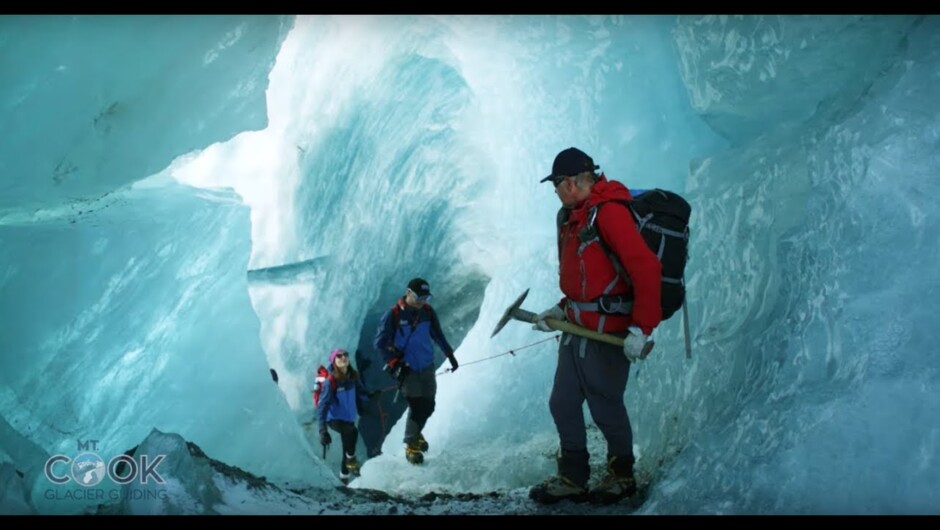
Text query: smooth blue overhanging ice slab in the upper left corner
0 15 291 208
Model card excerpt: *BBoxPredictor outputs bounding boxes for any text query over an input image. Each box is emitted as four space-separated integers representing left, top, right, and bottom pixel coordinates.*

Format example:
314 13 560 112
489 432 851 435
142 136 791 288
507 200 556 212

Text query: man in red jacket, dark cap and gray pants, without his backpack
529 147 662 503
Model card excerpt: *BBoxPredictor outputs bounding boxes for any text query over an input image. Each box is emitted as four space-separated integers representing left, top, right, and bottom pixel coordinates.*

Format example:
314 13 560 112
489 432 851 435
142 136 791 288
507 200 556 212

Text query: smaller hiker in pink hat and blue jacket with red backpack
317 348 373 481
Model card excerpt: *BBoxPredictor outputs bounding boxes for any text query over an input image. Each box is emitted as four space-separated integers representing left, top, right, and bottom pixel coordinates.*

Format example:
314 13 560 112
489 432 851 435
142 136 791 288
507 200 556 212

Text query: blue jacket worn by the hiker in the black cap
372 299 454 372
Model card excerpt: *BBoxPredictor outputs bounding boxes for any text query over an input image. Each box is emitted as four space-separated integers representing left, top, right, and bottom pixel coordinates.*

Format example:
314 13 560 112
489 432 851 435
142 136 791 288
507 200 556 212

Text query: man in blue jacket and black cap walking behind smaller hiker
372 278 458 464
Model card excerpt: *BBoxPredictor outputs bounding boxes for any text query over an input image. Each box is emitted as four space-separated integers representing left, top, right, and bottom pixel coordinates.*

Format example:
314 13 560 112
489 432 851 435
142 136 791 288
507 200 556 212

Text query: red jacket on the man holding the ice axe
558 174 662 335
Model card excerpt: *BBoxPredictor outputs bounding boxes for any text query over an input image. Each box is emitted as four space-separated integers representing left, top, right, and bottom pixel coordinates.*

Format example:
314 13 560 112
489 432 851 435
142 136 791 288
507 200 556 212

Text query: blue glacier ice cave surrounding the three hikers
0 15 940 514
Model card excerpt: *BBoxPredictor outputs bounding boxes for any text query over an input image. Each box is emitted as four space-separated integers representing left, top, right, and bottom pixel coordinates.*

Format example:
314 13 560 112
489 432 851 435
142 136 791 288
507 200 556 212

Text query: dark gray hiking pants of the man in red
548 333 633 484
